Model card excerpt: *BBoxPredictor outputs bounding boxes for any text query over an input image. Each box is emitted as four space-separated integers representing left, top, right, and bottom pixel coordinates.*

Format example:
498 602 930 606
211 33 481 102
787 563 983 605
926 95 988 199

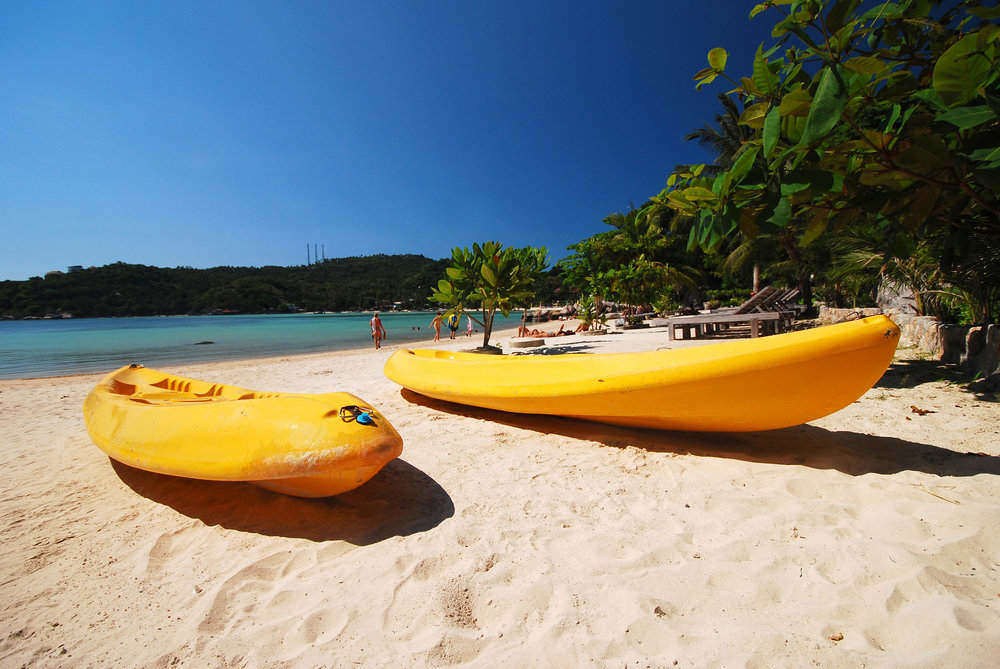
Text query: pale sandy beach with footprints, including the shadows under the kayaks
0 322 1000 668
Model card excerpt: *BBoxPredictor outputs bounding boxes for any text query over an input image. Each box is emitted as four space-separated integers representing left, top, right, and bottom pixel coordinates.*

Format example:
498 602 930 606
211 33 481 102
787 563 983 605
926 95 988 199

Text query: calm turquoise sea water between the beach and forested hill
0 312 521 379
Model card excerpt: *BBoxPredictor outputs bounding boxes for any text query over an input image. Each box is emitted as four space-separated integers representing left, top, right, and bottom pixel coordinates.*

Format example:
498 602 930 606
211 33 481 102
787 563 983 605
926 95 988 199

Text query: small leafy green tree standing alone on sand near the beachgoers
430 242 549 349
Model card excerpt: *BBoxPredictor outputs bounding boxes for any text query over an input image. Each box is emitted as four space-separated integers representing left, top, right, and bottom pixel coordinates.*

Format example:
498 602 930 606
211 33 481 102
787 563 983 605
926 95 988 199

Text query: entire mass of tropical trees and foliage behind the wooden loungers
544 0 1000 323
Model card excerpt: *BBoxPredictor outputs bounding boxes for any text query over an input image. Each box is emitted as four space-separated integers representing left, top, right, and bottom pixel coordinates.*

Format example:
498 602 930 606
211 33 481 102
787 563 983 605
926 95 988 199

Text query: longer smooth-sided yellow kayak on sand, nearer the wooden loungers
385 316 899 432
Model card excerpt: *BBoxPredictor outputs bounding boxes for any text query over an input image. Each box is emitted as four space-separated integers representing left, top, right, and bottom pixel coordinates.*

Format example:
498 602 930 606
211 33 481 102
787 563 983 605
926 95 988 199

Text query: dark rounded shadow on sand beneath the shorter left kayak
109 458 455 546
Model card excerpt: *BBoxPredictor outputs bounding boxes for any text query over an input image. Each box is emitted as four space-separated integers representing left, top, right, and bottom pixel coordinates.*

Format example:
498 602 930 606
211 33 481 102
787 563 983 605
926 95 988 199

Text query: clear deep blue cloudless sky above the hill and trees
0 0 774 280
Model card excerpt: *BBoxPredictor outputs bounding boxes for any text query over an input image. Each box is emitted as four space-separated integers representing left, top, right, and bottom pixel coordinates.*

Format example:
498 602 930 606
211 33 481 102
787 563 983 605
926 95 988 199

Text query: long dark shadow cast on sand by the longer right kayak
400 389 1000 476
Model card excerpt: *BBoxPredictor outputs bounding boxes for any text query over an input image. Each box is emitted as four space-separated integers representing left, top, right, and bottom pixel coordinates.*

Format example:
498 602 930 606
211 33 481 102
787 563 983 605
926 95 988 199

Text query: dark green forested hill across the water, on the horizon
0 255 447 318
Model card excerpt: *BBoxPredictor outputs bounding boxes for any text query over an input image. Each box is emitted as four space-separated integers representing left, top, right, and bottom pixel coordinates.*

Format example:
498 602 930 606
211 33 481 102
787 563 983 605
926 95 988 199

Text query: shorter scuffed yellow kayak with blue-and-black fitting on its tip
83 365 403 497
